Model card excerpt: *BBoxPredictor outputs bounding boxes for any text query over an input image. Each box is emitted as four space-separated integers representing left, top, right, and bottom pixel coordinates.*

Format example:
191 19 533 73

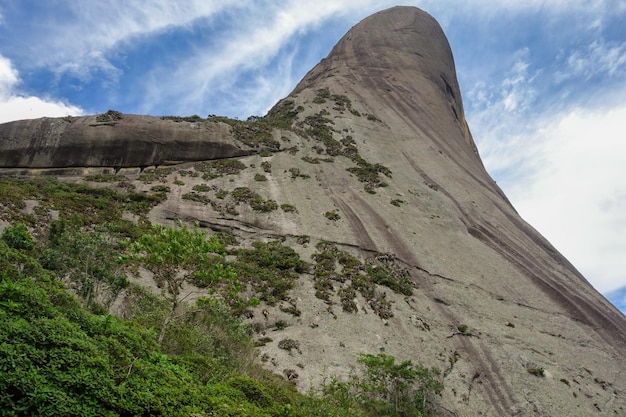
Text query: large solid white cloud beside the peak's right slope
498 105 626 292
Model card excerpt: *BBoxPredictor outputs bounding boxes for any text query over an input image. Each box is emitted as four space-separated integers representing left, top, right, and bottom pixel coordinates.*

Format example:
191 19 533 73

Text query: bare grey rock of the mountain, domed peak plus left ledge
0 7 626 416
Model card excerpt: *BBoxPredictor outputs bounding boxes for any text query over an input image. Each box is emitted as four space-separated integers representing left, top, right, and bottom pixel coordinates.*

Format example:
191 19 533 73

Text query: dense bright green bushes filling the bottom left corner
0 231 338 416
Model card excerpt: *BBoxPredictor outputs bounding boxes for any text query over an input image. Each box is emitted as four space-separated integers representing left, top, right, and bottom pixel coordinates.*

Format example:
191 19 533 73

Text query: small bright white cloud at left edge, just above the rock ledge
0 55 83 123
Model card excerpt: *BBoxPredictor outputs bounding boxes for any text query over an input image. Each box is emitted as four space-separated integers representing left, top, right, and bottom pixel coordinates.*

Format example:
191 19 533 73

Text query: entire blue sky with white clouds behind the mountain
0 0 626 312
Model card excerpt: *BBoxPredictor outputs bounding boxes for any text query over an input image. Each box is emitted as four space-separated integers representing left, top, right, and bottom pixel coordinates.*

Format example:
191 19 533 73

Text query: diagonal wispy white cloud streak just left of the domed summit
138 0 378 113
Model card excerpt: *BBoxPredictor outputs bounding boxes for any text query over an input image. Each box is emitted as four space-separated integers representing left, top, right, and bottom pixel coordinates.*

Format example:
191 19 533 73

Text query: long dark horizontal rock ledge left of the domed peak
0 111 250 168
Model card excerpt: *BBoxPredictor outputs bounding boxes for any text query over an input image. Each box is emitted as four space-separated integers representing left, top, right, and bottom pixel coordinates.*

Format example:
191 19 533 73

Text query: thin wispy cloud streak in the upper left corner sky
12 0 236 73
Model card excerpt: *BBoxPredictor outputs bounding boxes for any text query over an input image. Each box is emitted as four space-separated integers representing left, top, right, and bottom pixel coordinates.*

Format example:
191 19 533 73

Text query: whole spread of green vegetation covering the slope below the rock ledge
0 178 439 417
